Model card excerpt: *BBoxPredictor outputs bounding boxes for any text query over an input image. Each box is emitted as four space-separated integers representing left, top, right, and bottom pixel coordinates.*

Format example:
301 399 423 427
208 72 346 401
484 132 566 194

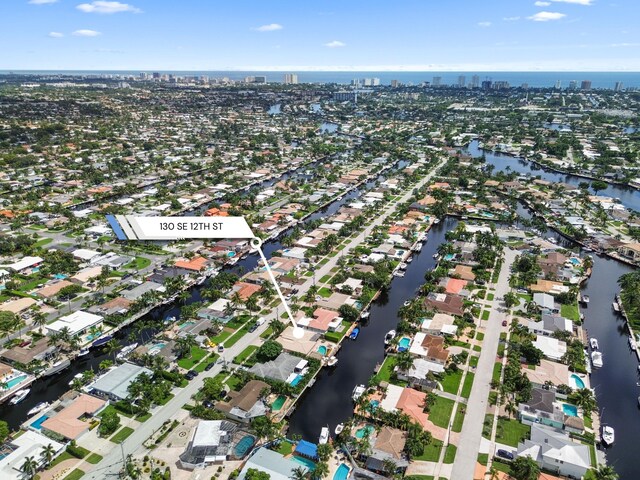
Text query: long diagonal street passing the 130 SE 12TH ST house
84 159 444 480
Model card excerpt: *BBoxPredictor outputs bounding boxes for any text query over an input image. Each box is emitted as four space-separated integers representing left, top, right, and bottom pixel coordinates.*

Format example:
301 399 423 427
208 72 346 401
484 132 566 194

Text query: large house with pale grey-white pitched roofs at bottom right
516 424 591 478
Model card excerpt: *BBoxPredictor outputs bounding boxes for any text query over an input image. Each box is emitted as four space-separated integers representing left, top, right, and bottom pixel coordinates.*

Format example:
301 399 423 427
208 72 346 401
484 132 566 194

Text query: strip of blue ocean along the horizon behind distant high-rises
0 70 640 88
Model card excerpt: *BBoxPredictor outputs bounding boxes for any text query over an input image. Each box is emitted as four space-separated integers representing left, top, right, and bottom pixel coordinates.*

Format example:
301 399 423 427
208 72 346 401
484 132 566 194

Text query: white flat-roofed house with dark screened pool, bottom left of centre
179 420 255 470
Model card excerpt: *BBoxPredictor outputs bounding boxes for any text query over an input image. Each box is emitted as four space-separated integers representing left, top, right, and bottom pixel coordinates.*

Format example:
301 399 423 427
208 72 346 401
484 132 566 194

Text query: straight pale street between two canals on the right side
451 248 517 480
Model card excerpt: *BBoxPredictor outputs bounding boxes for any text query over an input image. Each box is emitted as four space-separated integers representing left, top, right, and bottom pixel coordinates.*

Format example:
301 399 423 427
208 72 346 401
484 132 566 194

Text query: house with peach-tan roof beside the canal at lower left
41 393 108 440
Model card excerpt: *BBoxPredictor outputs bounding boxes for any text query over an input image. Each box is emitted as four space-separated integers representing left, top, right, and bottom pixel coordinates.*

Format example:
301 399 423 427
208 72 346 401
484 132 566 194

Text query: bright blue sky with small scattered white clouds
0 0 640 71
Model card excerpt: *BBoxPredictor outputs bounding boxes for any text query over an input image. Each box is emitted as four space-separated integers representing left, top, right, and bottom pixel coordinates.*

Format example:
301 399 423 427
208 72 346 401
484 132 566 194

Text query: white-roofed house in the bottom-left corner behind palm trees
0 430 65 480
